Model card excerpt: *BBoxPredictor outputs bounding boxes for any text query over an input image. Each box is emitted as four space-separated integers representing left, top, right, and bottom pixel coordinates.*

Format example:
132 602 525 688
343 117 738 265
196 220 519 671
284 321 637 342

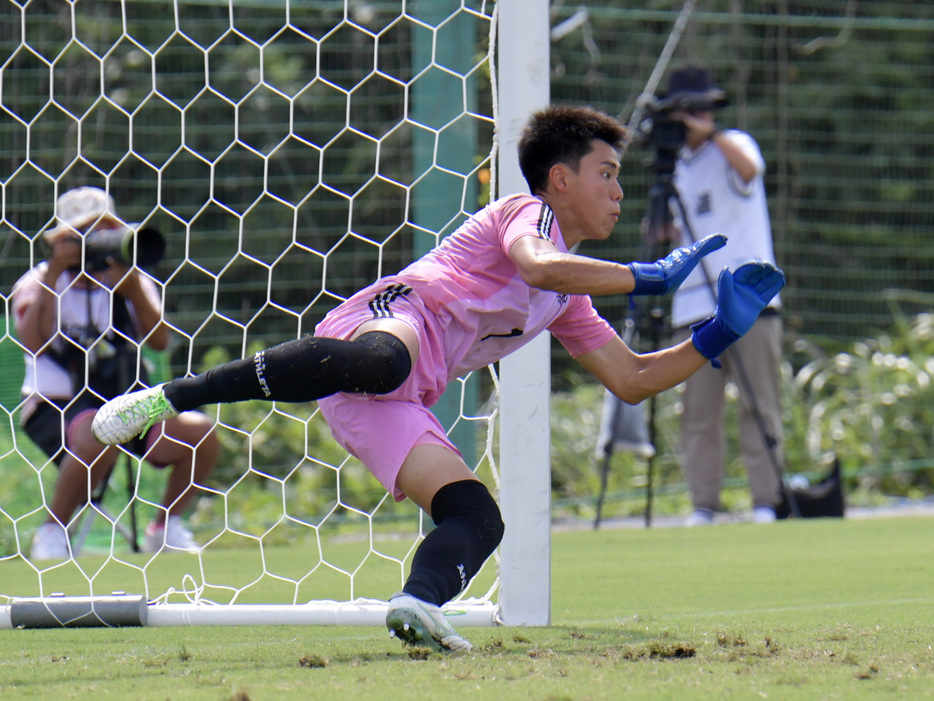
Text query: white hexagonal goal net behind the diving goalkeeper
0 0 549 626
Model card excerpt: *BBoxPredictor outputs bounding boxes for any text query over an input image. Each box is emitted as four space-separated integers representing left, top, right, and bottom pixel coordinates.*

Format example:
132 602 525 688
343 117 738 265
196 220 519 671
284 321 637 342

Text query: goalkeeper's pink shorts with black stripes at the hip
315 282 461 501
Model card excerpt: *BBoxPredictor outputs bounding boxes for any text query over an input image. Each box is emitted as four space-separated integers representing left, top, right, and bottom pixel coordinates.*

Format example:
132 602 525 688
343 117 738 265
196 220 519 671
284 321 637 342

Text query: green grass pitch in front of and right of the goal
0 517 934 701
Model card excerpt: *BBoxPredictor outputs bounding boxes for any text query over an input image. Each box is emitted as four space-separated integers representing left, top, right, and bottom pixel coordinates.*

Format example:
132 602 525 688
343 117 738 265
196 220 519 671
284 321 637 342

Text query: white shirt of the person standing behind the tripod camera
671 129 781 329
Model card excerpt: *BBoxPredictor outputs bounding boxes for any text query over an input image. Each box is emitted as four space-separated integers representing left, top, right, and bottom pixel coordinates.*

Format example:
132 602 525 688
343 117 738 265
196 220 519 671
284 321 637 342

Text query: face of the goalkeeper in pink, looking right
569 140 623 240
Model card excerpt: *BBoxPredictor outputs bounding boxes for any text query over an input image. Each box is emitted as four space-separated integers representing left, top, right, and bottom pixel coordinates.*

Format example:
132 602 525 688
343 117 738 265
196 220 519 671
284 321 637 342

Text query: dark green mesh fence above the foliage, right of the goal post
551 0 934 356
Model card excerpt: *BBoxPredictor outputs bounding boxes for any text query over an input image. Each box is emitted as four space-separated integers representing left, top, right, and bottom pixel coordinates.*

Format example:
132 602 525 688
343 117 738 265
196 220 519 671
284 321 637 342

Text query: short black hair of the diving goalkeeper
519 105 627 194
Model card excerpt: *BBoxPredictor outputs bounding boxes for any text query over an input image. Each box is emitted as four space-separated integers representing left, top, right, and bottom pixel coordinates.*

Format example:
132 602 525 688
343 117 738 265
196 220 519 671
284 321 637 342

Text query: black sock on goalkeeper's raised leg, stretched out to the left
164 331 412 411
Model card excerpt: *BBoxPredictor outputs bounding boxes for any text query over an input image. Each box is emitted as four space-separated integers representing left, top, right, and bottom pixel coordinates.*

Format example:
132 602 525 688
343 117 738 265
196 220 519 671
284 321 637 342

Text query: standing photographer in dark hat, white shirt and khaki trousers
666 64 783 525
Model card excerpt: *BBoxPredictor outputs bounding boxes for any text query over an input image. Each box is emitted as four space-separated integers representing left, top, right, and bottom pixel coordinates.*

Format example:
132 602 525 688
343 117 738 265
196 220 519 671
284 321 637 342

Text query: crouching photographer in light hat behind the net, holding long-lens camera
11 187 218 560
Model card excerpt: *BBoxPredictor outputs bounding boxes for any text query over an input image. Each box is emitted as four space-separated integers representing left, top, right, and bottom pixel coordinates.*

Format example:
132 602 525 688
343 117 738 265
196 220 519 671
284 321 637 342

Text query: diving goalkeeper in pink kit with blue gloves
93 105 784 650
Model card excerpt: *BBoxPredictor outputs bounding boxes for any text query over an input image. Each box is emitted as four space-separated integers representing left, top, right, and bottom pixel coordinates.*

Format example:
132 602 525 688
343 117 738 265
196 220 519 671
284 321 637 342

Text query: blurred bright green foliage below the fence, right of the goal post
552 303 934 518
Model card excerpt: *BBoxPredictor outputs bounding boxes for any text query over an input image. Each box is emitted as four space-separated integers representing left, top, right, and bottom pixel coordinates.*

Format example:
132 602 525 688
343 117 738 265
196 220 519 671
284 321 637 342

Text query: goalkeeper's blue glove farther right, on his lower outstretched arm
691 261 785 368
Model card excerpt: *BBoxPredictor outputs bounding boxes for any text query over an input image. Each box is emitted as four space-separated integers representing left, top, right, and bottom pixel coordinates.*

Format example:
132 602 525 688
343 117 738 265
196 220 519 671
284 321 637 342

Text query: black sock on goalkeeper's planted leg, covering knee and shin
402 480 503 606
